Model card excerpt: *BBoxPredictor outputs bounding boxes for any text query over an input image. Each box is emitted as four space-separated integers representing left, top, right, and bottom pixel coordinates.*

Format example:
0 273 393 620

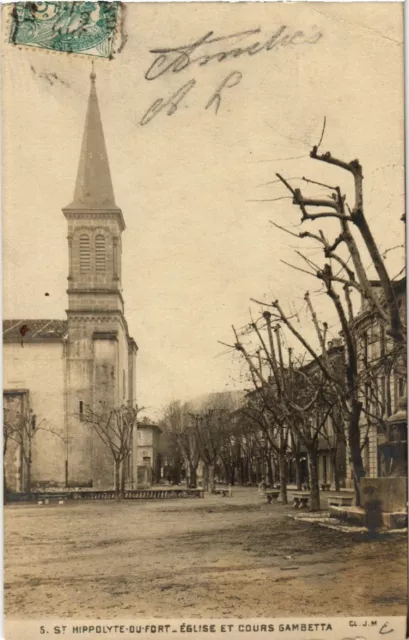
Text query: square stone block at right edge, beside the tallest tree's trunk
360 478 408 513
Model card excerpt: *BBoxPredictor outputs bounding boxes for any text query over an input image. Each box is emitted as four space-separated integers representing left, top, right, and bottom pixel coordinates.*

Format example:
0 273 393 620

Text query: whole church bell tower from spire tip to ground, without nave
63 69 137 488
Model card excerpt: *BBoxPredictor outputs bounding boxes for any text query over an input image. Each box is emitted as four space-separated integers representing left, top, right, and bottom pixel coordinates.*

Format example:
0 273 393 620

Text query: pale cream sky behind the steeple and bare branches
2 3 404 416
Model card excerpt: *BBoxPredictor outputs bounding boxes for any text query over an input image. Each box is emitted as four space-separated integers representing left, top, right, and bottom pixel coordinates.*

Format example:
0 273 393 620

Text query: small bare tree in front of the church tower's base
82 401 143 499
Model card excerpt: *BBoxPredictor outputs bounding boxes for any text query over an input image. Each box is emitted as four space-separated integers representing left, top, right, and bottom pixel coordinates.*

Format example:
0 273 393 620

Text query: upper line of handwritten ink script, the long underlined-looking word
145 25 322 80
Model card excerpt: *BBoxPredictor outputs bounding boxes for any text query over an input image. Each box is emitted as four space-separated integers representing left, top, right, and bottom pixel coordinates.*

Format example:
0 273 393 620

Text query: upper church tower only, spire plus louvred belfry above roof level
63 71 125 313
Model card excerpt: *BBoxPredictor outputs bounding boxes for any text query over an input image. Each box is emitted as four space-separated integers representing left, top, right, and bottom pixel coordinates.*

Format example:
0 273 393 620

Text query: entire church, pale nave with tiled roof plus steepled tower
3 72 138 491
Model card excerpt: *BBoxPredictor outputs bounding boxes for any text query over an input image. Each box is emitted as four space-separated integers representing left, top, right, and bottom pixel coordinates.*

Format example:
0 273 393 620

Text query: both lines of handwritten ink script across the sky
139 25 322 126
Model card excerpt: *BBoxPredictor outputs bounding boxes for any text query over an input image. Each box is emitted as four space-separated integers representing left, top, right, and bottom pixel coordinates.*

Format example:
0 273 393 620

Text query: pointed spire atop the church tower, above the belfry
68 67 118 209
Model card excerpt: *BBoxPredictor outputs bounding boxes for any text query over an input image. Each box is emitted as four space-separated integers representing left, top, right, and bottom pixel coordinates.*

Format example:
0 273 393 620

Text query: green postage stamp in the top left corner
10 2 119 58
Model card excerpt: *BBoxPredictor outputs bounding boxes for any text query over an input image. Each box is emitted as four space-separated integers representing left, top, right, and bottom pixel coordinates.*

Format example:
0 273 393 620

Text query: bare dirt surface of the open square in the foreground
4 488 407 619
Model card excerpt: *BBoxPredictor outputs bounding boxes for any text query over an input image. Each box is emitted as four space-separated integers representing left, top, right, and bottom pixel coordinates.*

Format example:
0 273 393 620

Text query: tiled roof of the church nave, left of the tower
3 319 68 342
